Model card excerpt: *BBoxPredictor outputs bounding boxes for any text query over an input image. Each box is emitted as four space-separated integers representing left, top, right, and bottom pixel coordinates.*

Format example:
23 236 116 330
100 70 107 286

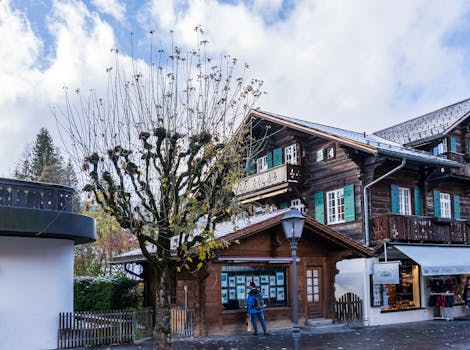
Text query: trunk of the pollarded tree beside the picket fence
153 264 171 350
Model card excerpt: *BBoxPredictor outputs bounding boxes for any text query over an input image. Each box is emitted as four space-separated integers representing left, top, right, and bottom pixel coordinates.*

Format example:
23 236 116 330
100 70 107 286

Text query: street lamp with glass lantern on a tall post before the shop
281 208 305 335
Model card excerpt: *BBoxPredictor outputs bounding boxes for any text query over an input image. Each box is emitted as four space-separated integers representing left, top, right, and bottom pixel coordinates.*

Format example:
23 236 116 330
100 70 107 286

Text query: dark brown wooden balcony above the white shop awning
371 214 470 244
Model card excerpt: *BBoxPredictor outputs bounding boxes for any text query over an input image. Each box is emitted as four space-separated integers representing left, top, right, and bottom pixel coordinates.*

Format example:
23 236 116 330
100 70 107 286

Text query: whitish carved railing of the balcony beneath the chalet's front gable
235 164 303 196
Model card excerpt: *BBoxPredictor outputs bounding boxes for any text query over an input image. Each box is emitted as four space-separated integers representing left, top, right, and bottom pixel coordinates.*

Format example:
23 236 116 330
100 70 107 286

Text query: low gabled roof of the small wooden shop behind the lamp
112 209 373 264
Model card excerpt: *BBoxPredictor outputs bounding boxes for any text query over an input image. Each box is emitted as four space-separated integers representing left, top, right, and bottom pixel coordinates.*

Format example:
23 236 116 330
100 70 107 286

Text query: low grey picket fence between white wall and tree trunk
57 308 154 349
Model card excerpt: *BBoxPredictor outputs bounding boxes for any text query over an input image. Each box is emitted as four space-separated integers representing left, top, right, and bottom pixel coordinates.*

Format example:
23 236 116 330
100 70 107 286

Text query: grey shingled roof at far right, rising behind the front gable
374 99 470 146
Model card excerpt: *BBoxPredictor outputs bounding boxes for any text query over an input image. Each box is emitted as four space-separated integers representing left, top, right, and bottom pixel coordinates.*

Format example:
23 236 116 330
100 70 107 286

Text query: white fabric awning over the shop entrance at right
393 244 470 276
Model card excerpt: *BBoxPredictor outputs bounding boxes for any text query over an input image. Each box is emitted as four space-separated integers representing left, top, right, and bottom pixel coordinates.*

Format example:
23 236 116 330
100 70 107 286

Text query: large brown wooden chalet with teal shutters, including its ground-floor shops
116 99 470 335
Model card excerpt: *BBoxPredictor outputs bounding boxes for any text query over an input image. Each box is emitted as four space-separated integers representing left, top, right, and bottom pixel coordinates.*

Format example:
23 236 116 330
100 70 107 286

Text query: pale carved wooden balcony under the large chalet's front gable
235 164 304 200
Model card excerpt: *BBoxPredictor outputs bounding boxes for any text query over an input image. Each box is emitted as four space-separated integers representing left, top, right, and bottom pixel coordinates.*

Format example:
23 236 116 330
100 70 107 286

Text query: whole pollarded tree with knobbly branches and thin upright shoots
54 28 262 349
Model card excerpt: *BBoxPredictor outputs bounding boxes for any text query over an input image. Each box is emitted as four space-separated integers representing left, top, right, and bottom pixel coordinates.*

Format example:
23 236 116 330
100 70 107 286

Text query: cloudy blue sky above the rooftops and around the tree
0 0 470 177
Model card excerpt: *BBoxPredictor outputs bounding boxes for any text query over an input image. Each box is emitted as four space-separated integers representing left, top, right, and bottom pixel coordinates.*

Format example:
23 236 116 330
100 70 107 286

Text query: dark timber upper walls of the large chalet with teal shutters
244 109 470 244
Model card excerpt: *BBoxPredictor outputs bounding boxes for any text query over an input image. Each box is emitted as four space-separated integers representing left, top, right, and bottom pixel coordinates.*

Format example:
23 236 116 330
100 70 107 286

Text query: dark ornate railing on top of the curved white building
0 178 74 212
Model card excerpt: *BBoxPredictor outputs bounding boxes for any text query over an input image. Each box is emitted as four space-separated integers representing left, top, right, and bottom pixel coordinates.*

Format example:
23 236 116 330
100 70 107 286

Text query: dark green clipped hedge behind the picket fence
73 275 137 311
